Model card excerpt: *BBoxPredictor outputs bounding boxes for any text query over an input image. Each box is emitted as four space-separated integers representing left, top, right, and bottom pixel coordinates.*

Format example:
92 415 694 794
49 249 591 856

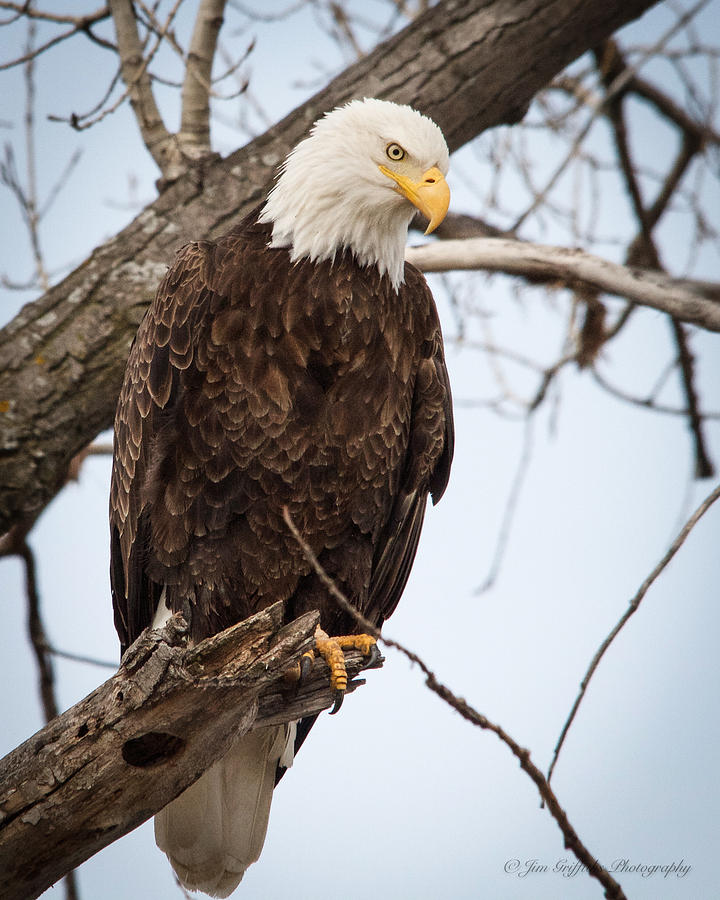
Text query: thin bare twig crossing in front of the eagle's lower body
283 506 632 900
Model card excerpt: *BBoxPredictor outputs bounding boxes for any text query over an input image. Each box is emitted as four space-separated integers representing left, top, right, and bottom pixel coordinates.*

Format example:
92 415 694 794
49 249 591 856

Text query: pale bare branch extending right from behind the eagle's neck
405 238 720 331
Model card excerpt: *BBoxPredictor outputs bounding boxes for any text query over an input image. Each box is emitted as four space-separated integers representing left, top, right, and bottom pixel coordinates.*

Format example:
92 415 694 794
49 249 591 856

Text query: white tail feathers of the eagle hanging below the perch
155 725 295 897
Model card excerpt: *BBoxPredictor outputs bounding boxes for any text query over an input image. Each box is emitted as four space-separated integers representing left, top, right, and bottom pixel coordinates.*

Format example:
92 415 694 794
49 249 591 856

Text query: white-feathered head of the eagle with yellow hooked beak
260 99 450 289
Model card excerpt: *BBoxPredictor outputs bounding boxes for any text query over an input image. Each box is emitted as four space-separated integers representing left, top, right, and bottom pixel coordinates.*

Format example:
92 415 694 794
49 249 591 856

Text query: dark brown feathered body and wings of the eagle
111 212 452 649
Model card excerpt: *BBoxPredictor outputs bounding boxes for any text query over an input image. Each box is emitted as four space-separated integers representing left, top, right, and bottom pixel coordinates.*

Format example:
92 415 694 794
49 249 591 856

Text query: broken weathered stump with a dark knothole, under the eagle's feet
0 604 382 900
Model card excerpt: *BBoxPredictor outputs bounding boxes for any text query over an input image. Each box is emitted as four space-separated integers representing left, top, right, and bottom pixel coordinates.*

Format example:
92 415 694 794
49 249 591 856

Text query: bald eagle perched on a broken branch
110 99 453 897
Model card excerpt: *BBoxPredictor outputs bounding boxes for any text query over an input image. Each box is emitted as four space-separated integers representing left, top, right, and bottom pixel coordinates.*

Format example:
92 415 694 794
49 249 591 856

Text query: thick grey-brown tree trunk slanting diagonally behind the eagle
0 0 655 534
